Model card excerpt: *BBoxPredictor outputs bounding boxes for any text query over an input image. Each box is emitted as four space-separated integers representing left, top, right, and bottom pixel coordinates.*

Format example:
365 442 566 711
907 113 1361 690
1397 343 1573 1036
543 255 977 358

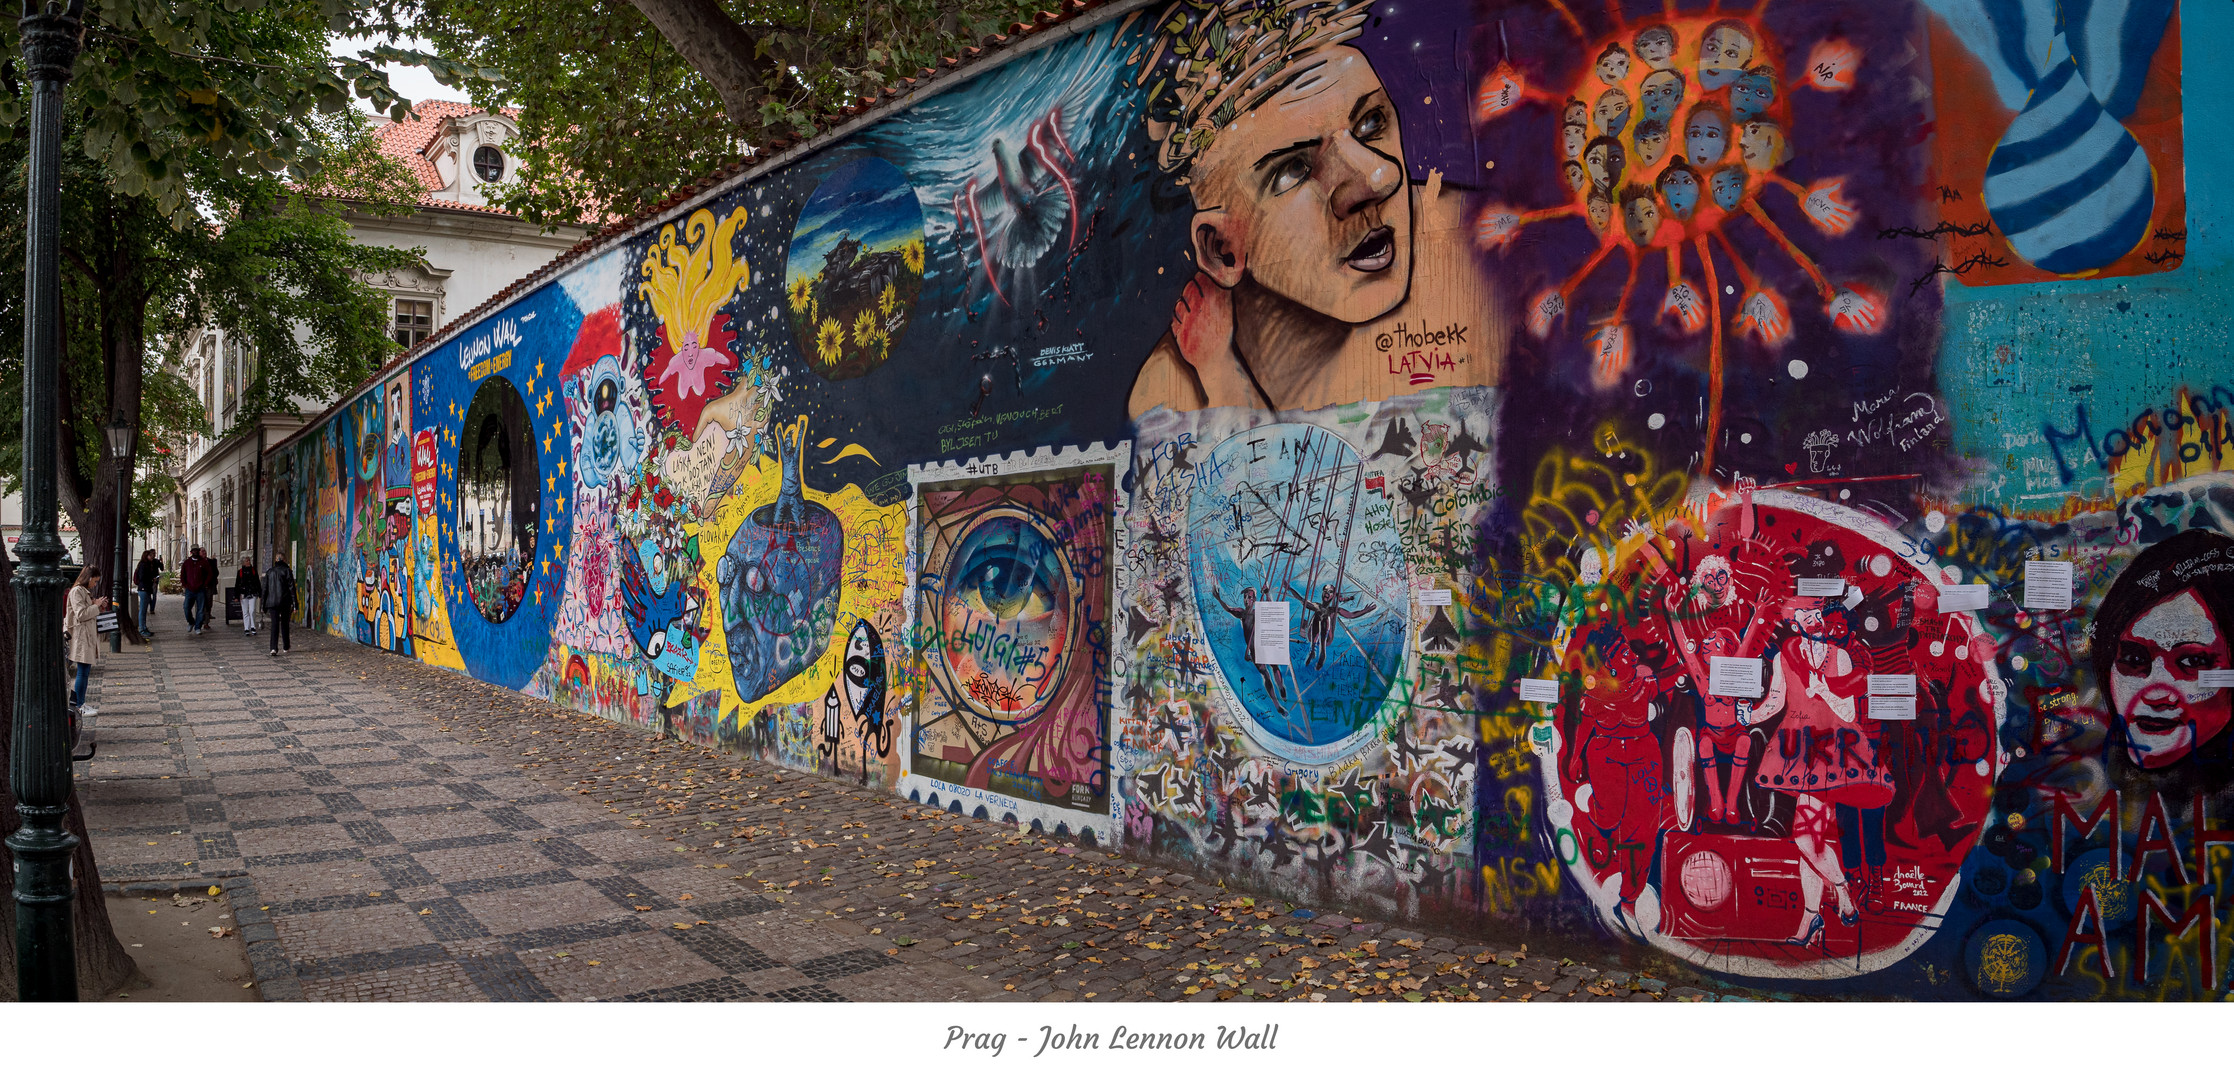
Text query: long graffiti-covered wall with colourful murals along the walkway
266 0 2234 1000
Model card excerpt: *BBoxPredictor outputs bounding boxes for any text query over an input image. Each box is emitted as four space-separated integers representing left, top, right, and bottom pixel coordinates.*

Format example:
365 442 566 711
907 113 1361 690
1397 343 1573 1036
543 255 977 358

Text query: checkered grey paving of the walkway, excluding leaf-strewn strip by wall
80 635 985 1002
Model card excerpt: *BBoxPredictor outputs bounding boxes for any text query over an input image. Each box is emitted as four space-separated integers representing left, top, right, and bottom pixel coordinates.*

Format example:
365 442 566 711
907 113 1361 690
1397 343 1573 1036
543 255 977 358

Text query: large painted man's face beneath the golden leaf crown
1193 45 1412 322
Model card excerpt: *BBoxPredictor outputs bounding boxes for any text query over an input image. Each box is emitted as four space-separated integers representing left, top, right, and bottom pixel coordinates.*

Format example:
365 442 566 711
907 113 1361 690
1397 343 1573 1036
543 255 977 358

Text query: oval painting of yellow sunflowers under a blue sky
784 157 923 380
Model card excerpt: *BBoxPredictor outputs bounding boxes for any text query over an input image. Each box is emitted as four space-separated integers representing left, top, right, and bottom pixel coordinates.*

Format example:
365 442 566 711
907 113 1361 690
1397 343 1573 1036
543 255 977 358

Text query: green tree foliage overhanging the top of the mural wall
411 0 1054 224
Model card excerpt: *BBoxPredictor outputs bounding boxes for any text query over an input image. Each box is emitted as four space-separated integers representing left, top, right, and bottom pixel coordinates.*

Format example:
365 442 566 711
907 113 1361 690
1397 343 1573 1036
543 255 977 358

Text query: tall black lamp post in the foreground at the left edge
7 0 85 1002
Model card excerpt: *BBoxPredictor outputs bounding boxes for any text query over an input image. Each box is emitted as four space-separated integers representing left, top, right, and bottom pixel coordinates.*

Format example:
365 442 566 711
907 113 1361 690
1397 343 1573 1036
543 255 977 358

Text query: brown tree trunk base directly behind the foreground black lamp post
0 559 145 1002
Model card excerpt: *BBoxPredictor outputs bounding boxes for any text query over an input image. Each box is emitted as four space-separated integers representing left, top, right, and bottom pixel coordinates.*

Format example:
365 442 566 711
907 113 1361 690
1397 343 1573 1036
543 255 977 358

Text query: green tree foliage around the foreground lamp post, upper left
0 0 444 561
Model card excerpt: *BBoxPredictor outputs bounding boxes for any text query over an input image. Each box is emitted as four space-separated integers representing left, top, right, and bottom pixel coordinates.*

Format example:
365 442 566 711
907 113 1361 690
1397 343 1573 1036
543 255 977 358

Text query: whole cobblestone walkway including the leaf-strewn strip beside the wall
80 628 1716 1002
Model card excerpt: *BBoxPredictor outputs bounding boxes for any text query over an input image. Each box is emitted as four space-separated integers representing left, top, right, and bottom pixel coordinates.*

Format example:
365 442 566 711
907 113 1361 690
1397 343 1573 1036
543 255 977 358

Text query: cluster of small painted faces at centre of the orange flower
1559 20 1792 246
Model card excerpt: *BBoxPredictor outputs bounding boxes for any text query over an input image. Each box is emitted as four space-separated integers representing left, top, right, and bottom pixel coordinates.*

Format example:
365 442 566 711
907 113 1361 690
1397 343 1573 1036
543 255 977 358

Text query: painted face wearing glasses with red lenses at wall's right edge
2109 588 2234 769
